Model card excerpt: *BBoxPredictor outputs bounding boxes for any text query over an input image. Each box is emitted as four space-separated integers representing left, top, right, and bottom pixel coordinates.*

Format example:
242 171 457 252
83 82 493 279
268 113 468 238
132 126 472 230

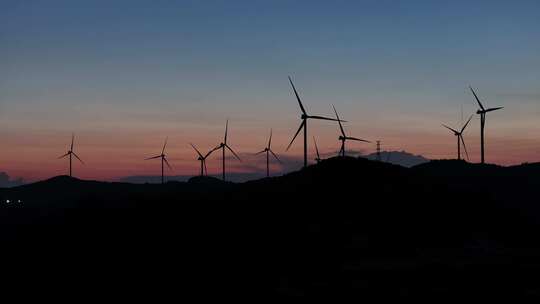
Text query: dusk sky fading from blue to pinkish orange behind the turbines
0 0 540 181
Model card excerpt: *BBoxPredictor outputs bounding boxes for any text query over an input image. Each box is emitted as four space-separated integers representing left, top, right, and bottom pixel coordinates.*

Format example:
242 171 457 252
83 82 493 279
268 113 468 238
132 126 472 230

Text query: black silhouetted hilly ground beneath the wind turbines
0 158 540 302
